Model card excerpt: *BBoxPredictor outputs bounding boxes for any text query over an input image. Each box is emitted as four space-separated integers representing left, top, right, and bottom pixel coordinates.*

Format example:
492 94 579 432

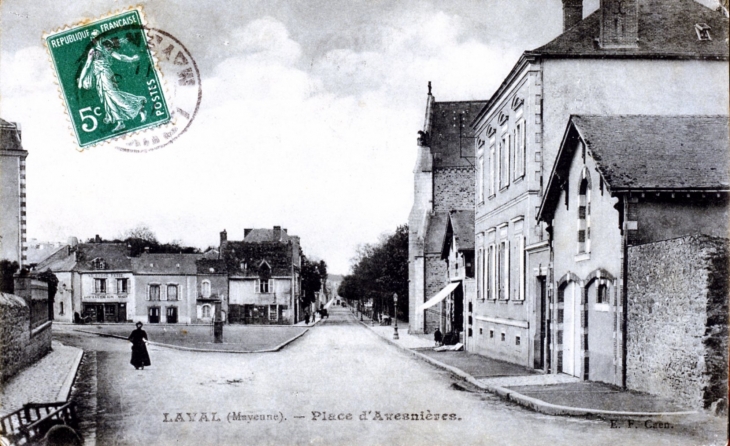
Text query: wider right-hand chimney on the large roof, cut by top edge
599 0 639 48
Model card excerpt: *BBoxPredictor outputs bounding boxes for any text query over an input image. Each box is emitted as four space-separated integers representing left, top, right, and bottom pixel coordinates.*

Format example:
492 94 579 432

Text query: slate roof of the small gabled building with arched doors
540 115 730 218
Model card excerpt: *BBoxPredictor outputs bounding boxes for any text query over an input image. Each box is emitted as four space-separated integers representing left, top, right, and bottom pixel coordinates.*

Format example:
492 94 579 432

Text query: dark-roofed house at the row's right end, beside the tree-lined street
220 226 304 324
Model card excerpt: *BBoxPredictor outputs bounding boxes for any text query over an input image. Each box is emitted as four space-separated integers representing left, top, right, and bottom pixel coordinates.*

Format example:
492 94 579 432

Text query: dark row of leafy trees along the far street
337 225 408 321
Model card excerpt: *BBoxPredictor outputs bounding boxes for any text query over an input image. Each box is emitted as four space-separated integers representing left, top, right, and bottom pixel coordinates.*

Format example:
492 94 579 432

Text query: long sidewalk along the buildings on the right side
362 321 703 420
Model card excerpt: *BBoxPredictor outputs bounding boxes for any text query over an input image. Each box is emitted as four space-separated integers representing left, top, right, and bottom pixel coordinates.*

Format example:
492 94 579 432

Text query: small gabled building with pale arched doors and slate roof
538 115 730 390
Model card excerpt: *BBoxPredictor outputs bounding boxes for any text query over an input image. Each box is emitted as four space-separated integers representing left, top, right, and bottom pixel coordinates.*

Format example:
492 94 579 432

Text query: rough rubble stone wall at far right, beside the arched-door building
626 235 728 411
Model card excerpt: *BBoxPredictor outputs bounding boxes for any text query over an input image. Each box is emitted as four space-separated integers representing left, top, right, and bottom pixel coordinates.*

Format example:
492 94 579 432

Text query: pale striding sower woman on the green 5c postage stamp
78 30 147 132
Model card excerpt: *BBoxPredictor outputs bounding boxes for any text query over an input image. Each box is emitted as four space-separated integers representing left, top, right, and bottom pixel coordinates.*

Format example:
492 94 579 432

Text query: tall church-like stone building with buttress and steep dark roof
408 83 486 333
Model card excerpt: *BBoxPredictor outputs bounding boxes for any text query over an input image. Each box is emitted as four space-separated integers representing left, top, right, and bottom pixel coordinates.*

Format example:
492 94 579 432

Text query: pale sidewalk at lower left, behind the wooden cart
0 341 84 415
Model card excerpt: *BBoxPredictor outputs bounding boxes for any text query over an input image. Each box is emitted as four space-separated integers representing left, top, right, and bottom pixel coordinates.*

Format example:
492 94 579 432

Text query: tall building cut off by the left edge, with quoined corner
0 119 28 266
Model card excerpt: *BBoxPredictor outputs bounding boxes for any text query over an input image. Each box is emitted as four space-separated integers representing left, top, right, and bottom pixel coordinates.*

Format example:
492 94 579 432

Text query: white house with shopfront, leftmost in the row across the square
35 237 135 322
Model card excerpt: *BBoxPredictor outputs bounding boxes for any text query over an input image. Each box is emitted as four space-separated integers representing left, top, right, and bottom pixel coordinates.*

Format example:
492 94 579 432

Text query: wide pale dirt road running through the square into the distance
58 308 716 445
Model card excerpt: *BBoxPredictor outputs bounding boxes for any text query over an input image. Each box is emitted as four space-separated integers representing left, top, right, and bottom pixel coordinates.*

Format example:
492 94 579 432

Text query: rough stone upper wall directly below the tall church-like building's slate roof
433 167 476 212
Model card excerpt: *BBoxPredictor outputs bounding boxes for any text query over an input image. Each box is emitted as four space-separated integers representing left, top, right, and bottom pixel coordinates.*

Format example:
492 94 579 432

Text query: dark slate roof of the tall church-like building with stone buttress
429 101 487 168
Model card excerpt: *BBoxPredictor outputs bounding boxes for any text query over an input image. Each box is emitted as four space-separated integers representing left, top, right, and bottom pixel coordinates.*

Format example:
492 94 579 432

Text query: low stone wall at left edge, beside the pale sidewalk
0 293 51 382
